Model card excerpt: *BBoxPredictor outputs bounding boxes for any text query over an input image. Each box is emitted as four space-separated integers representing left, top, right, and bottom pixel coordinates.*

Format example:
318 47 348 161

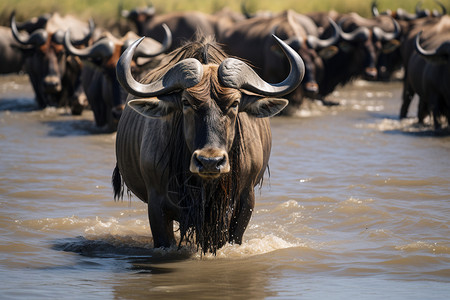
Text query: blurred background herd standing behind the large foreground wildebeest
0 2 450 130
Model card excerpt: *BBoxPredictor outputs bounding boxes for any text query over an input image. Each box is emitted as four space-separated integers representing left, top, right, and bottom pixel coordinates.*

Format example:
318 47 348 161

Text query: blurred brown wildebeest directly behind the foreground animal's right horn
219 10 339 115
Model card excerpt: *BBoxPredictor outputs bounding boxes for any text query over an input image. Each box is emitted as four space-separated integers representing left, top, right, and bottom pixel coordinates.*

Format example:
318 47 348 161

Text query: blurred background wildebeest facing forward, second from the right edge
308 12 400 97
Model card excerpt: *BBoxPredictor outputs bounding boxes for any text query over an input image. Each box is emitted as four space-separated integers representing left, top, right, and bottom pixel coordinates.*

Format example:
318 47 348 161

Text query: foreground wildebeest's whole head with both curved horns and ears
117 37 305 179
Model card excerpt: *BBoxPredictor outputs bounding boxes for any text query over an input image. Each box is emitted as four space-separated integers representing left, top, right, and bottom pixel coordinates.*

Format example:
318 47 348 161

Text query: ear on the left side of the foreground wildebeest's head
128 96 175 118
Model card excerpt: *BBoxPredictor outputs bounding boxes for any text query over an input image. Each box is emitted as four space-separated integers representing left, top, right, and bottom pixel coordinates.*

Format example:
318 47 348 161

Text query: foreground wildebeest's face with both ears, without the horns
129 65 288 179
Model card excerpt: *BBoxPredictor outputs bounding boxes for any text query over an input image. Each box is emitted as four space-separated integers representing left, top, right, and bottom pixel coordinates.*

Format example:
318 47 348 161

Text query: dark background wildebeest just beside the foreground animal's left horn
64 26 172 131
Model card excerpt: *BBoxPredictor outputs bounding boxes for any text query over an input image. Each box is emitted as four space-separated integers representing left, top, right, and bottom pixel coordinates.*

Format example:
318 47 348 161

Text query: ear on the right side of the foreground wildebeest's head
239 95 289 118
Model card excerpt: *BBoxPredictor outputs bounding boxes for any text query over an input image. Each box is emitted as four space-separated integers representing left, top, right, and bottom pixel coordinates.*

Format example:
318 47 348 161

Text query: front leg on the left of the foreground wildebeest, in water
148 193 175 248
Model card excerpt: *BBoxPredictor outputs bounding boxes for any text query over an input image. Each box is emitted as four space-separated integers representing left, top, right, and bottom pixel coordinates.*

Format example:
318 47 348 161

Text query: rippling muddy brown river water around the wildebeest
0 76 450 299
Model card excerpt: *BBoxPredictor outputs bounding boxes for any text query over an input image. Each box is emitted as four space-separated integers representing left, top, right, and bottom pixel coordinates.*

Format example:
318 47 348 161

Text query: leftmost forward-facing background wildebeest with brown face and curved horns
11 12 94 114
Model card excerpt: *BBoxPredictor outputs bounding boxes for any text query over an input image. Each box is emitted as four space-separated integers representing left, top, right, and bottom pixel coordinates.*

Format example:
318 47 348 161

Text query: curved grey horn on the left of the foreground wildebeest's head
116 37 203 97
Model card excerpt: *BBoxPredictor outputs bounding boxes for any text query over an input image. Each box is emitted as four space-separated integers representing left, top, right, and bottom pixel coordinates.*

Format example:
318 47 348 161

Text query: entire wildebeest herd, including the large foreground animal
0 2 450 253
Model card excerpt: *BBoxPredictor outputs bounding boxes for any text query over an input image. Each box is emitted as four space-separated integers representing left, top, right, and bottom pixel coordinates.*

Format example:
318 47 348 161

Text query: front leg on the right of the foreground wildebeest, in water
230 188 255 244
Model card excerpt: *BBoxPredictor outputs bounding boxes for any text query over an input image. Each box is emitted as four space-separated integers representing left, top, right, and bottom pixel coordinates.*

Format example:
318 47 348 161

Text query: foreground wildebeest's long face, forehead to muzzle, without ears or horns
181 66 241 178
